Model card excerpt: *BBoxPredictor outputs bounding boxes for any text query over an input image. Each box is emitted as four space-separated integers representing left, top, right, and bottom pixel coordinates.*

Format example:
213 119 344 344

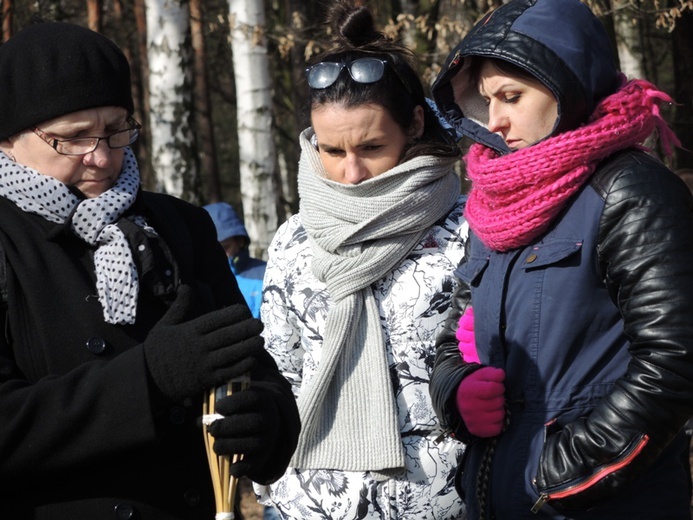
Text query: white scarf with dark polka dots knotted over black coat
0 148 153 324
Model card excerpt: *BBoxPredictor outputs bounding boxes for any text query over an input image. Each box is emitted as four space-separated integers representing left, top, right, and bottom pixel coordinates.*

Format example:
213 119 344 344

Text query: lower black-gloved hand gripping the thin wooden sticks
209 383 283 479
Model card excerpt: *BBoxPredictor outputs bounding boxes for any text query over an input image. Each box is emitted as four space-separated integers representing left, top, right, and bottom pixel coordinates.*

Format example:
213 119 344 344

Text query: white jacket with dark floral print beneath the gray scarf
255 197 468 520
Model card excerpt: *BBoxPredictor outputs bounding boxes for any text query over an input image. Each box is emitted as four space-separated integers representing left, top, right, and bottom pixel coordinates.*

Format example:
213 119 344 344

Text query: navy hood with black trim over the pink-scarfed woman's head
432 0 619 151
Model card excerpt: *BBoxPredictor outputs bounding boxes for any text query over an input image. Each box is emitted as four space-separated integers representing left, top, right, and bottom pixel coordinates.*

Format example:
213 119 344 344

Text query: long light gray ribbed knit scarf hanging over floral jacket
291 128 460 475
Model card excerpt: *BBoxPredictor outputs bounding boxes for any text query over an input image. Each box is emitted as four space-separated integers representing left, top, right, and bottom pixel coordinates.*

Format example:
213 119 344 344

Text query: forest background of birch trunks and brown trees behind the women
0 0 693 257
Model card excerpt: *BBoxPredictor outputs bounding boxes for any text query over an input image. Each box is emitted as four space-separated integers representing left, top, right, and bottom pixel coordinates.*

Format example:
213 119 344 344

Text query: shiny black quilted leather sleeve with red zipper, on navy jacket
537 152 693 509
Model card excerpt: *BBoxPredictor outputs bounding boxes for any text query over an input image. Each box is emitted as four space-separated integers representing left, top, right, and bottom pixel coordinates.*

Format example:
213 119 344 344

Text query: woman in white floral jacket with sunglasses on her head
258 2 467 520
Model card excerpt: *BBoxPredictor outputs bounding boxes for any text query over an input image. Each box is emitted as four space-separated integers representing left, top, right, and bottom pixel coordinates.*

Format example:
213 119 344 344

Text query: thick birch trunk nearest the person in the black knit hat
145 0 200 204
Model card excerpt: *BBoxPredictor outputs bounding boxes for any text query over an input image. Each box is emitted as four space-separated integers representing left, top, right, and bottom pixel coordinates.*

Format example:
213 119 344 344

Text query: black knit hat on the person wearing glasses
0 22 134 140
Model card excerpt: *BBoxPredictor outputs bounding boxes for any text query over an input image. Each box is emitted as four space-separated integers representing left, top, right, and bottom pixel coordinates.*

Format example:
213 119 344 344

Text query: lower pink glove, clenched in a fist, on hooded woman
456 367 505 437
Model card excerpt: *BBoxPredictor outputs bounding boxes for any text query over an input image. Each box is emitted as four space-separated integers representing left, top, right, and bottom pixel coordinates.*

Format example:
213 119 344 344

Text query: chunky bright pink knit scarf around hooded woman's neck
465 76 680 251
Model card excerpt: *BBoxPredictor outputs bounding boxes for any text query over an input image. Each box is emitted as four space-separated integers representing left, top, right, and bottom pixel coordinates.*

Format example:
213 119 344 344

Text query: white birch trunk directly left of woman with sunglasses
229 0 284 258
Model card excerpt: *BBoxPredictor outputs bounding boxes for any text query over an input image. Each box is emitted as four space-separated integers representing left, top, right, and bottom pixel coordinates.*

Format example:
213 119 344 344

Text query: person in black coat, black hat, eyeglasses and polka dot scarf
0 22 300 520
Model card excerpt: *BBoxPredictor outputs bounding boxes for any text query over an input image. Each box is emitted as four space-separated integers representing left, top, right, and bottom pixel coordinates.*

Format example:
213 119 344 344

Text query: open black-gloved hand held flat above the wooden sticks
144 285 266 401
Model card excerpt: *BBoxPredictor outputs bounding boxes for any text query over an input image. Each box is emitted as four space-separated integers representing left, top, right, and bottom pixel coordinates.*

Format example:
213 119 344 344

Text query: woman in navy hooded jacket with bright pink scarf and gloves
431 0 693 520
